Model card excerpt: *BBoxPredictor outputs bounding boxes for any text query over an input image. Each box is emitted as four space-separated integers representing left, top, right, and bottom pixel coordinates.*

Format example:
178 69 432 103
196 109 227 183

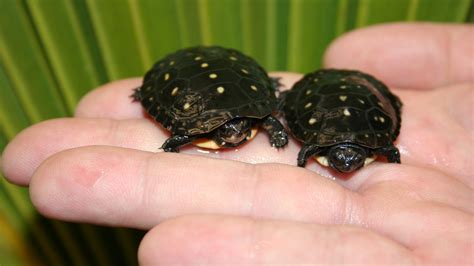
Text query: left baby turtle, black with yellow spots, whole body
132 46 288 152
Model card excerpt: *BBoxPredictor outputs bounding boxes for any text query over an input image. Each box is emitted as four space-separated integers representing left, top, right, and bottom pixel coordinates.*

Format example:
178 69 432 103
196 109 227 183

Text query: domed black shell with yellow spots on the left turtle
134 46 277 135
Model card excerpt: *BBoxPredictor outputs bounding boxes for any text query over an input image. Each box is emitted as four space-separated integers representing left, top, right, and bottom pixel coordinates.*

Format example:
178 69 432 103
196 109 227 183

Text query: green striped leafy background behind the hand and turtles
0 0 474 265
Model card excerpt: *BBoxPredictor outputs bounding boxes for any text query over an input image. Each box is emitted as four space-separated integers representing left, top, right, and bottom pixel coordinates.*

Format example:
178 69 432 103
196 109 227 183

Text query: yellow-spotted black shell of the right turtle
284 69 402 148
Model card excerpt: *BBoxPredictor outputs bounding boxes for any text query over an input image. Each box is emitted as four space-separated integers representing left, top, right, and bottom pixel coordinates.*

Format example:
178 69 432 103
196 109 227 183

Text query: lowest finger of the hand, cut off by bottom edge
138 216 418 265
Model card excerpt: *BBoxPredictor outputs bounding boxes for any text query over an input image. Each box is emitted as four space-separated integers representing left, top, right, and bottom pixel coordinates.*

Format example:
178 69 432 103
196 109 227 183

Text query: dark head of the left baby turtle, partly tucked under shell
214 118 252 147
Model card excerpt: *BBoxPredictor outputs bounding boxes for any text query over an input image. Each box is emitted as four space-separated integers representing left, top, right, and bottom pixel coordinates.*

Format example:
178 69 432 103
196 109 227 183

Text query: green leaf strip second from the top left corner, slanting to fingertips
27 0 106 112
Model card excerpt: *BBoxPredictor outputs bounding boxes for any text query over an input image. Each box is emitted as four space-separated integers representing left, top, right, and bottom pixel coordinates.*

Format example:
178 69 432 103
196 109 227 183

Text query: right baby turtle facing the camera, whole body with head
284 69 402 173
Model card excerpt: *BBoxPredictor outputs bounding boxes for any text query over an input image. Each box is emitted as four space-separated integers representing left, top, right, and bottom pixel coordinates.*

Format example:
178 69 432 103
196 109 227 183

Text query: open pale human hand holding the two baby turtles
2 24 474 265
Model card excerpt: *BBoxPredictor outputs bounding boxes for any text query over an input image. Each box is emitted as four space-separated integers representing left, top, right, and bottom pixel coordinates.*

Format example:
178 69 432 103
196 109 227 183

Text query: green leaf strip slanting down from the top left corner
0 0 66 122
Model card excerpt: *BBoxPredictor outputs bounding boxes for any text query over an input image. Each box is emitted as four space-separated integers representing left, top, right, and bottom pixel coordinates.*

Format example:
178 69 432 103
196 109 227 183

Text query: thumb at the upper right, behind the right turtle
324 23 474 89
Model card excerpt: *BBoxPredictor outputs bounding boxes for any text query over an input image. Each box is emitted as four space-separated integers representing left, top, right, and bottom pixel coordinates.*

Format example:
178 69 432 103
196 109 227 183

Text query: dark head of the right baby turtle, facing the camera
327 143 367 173
